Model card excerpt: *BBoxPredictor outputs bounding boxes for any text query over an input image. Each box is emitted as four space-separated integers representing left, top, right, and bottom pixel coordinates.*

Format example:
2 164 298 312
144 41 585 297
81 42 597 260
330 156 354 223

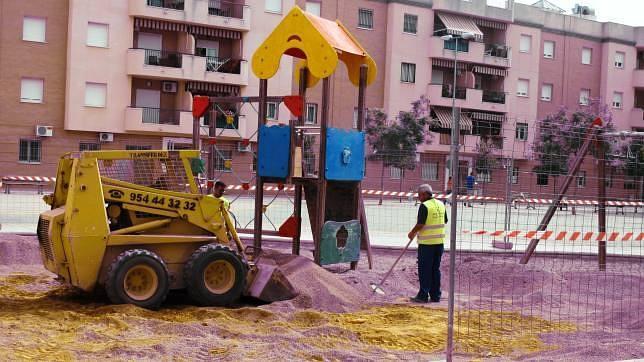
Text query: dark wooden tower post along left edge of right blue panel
313 77 331 265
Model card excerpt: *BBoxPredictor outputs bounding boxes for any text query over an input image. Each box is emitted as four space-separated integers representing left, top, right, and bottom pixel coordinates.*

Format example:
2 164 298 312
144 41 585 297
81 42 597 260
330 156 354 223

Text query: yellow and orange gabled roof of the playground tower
252 6 377 86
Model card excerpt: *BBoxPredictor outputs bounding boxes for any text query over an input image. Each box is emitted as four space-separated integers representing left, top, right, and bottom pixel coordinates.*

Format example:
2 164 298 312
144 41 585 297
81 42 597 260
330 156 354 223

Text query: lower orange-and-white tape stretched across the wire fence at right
461 230 644 241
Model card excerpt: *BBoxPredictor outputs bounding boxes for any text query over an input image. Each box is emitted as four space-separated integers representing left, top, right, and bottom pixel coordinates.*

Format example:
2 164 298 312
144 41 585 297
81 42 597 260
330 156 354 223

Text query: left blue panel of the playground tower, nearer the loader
257 126 291 178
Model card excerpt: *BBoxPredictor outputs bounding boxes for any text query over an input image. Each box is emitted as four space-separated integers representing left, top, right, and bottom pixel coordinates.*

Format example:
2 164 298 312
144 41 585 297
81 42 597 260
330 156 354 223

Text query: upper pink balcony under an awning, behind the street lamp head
428 36 511 68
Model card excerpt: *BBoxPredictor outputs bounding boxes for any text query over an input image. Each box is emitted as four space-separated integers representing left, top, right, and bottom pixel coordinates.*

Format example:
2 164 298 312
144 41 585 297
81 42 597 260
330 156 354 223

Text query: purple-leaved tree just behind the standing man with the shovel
365 96 431 204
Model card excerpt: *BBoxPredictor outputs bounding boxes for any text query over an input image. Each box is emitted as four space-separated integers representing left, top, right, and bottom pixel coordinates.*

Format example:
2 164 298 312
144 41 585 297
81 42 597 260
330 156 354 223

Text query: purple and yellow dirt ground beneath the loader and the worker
0 234 644 361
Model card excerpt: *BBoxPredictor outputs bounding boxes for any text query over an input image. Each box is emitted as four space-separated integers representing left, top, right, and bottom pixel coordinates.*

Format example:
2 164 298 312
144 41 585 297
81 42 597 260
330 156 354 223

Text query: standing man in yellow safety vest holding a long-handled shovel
407 184 447 303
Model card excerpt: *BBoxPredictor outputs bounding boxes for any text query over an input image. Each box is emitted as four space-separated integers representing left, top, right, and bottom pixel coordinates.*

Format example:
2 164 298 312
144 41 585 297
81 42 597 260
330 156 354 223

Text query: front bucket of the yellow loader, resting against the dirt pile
246 252 297 303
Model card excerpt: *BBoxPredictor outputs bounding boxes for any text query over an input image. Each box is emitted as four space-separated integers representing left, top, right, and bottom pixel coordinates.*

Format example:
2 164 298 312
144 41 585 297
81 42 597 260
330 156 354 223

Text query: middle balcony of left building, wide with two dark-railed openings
127 49 248 85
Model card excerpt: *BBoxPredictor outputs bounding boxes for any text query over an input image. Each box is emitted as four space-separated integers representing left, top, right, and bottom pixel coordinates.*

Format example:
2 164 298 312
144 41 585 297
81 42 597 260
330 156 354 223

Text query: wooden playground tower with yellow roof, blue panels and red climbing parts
193 6 376 269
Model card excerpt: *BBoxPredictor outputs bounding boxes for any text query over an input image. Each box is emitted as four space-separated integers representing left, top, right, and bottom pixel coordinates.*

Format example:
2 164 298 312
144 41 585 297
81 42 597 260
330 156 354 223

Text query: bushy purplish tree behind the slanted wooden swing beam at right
532 100 616 192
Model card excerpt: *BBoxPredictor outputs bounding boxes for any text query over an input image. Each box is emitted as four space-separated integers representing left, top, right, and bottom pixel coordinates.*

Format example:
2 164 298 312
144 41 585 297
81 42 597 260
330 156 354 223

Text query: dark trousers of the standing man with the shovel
416 244 443 300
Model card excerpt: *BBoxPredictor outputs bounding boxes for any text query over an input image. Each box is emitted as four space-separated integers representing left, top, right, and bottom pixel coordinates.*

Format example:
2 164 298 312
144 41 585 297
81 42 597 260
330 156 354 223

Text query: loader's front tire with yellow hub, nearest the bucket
183 244 248 306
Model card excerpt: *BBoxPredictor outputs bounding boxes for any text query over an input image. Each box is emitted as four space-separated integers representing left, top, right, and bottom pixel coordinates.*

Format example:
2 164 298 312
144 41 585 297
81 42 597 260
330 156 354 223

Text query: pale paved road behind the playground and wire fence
0 193 644 256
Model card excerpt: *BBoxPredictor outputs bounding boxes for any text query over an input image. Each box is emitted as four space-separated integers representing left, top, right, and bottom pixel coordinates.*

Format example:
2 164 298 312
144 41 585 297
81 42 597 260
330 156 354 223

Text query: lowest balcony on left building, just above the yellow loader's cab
125 107 192 136
